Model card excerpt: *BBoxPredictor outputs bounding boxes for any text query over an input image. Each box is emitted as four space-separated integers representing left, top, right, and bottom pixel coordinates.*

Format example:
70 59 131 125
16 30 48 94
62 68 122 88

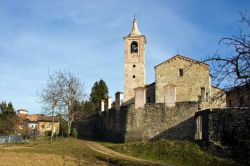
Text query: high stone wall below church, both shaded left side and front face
98 102 198 142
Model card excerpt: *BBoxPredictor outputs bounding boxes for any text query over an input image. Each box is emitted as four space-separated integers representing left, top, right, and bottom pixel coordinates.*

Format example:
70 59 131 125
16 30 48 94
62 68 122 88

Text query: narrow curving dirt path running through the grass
84 141 167 166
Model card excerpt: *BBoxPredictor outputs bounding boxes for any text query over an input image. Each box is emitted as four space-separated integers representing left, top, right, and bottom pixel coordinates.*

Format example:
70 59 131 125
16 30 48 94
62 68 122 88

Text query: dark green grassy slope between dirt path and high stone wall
102 140 240 166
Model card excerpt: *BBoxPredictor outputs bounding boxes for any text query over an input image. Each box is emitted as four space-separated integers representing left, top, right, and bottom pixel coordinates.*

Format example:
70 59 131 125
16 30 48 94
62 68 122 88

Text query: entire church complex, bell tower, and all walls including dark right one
74 20 250 163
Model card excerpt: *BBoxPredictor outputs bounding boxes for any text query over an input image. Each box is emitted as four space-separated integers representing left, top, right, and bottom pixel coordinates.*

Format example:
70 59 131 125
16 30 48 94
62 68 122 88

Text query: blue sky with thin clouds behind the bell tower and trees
0 0 250 113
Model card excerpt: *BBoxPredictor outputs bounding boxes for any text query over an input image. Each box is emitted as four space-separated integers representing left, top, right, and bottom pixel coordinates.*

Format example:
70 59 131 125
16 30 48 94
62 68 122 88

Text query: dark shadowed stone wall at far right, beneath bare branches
196 108 250 164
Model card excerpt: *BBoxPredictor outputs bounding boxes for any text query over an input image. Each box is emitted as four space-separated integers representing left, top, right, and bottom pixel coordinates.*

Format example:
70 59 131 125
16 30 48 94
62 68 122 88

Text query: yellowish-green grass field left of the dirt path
0 138 148 166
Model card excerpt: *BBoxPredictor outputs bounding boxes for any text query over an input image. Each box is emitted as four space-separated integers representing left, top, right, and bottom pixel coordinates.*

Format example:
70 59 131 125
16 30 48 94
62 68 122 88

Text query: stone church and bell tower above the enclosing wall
124 19 226 108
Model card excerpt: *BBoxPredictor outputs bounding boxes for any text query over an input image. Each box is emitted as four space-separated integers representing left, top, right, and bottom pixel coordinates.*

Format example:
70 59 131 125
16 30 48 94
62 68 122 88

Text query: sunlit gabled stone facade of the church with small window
155 56 211 103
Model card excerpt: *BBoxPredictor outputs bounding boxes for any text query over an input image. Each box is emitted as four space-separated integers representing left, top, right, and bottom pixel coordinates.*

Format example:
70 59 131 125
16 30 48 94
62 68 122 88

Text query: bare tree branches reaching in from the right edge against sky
205 13 250 90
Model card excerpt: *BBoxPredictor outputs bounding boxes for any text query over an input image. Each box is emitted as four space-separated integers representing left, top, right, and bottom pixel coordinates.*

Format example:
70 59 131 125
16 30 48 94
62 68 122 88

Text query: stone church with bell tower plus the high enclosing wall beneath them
75 19 248 153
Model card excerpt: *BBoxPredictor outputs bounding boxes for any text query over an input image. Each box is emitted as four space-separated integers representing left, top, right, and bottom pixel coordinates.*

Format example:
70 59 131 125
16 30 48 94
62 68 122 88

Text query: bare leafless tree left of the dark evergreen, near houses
39 71 84 139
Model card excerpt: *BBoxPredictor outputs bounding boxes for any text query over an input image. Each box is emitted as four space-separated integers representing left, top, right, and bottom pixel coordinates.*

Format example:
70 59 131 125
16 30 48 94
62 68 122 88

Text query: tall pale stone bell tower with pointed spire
124 18 146 104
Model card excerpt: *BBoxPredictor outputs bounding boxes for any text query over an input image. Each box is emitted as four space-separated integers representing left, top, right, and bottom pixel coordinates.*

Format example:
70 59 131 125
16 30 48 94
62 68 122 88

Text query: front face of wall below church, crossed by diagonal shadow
125 102 197 142
